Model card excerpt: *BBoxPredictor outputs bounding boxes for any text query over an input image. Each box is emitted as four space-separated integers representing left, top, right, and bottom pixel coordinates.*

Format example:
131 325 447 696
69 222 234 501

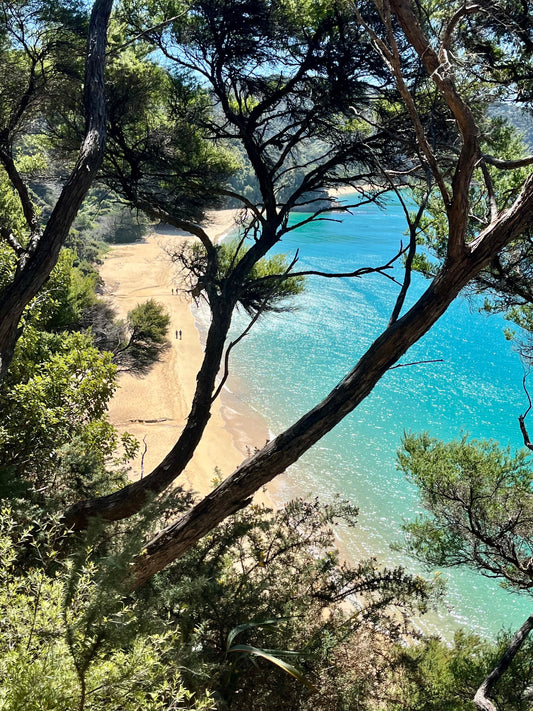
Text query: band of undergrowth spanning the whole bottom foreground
0 491 531 711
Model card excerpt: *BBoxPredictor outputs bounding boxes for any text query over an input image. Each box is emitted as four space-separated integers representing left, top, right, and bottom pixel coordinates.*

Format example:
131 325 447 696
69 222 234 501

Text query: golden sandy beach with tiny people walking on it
100 210 270 503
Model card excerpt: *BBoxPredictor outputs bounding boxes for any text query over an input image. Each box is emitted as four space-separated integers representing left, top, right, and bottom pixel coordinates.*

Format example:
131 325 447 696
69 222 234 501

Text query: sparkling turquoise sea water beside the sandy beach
227 195 531 634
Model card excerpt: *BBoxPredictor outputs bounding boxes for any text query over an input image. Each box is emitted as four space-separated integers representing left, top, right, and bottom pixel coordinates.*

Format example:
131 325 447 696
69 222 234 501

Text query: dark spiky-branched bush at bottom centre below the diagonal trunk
141 500 431 711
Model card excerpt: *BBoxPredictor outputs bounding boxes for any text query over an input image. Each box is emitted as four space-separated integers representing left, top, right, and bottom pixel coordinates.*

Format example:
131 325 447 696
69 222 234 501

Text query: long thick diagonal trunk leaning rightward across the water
125 176 533 588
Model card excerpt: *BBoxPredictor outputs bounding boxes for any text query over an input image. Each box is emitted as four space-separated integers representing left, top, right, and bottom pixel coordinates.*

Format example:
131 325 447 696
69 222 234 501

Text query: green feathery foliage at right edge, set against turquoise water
398 434 533 592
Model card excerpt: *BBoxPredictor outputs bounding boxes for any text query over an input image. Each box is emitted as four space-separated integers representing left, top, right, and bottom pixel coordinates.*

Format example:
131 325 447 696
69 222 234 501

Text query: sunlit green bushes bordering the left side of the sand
0 234 169 505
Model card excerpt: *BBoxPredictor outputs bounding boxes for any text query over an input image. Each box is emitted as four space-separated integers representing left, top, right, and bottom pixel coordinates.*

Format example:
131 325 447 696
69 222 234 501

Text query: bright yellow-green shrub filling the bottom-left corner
0 509 213 711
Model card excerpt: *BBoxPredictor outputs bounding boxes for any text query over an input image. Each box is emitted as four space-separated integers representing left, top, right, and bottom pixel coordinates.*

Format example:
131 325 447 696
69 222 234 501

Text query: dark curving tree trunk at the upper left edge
0 0 113 379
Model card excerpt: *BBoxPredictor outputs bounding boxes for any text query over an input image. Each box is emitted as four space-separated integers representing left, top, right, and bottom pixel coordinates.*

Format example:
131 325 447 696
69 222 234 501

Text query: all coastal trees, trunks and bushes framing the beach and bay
0 0 533 711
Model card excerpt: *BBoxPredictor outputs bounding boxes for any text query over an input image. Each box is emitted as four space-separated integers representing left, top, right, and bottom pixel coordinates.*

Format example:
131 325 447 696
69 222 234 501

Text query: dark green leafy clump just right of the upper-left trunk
95 39 237 220
